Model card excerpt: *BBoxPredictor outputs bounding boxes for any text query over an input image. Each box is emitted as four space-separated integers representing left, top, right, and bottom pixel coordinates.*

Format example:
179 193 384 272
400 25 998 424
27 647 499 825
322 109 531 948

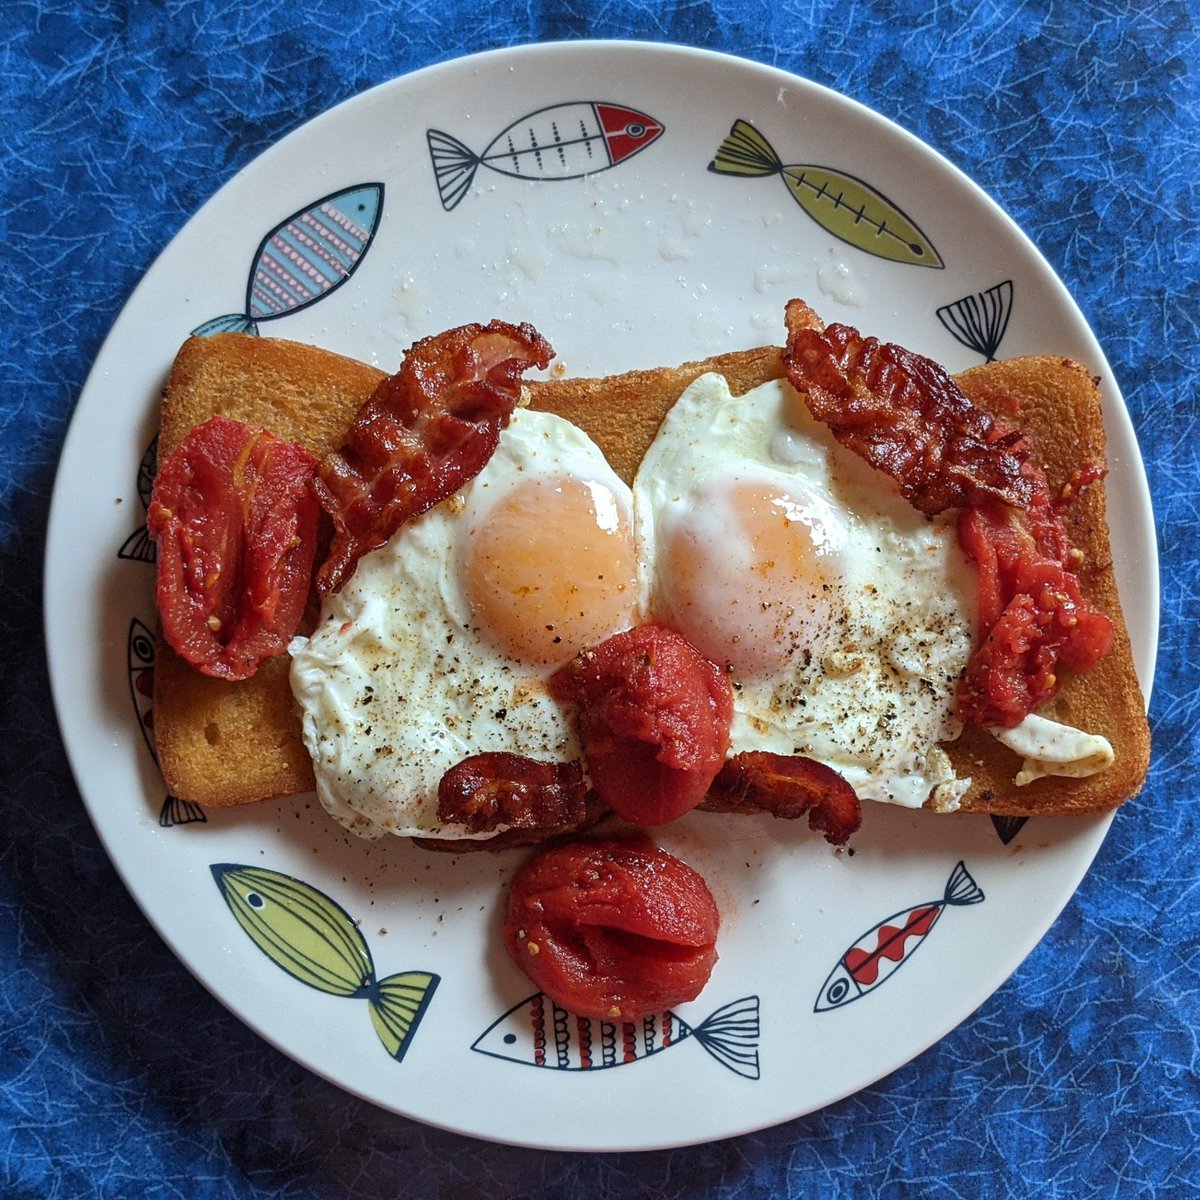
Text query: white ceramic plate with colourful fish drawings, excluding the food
46 43 1158 1150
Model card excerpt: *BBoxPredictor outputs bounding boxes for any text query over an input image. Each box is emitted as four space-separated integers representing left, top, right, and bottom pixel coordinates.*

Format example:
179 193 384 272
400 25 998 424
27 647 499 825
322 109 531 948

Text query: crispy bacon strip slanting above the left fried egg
313 320 554 593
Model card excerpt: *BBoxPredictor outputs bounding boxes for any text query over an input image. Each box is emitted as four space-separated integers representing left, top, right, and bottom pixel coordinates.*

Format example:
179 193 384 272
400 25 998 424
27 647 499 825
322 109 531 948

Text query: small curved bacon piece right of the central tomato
700 750 863 846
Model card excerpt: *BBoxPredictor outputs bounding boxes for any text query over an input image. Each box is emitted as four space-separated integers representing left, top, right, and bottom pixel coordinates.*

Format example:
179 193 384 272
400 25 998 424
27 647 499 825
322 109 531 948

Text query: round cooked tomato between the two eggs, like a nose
551 625 733 826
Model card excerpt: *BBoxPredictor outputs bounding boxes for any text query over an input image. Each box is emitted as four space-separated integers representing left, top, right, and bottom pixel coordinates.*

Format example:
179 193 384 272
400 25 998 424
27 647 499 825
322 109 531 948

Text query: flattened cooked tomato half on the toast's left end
146 416 319 679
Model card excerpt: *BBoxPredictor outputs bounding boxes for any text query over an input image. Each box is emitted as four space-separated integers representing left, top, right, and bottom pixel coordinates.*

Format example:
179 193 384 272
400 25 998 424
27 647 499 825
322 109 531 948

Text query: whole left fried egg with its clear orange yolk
290 409 638 838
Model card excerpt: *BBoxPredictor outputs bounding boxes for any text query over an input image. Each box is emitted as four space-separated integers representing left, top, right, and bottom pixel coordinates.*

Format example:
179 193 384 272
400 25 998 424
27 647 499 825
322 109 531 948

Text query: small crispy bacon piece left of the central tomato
438 751 588 833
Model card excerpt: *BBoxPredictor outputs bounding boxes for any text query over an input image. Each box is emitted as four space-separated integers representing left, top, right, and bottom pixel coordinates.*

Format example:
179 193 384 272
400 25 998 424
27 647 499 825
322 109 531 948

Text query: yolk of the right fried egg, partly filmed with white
654 481 839 678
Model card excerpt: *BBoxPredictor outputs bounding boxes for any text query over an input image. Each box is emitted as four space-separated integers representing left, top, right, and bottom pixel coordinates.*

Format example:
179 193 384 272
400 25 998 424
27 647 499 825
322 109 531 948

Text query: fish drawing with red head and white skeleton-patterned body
425 100 662 212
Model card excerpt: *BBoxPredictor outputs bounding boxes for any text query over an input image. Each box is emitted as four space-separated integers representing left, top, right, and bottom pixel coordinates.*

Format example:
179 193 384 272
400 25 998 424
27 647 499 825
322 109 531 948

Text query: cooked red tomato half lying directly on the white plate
504 834 720 1021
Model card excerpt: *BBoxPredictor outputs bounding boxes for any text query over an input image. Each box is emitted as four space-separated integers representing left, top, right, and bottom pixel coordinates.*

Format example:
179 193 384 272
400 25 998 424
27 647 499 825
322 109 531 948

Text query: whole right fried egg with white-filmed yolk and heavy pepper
634 374 977 808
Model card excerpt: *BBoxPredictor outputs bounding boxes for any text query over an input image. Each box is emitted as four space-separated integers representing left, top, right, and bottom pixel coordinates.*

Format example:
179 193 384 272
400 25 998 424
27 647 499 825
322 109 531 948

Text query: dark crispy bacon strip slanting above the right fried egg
784 300 1034 516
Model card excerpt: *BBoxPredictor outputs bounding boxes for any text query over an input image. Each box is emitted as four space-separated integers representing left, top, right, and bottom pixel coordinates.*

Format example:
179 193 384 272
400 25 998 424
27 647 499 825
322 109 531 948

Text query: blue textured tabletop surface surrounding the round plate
0 0 1200 1200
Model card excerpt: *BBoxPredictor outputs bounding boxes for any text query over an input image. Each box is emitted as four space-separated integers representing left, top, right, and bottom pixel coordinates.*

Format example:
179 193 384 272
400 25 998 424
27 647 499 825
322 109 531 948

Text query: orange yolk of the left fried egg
466 476 637 666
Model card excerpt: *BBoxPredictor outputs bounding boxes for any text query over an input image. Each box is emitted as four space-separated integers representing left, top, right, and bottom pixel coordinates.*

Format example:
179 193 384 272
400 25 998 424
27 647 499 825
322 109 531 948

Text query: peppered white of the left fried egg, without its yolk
290 409 631 839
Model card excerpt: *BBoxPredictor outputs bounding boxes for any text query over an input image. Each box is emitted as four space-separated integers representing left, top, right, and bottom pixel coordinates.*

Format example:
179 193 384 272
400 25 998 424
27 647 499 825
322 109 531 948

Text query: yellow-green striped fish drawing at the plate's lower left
210 863 440 1062
